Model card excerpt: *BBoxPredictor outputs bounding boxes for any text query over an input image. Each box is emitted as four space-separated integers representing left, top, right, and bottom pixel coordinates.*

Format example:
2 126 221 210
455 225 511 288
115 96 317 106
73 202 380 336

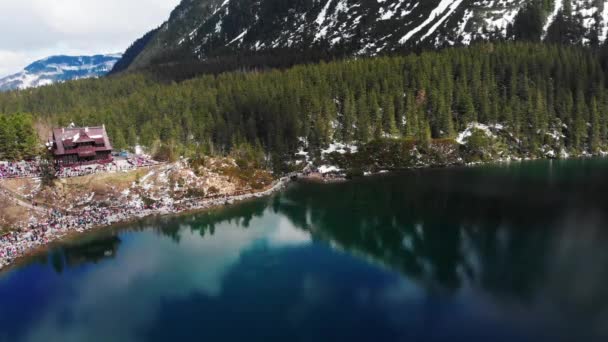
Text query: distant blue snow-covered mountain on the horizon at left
0 54 122 91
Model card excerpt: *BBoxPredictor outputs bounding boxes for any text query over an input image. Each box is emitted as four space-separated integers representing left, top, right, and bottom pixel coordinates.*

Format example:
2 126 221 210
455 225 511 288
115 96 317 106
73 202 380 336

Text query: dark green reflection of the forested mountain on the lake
275 161 608 337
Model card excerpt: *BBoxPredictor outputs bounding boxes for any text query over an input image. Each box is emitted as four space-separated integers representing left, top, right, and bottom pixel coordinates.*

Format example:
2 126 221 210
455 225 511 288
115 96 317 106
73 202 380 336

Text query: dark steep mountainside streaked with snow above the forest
121 0 608 70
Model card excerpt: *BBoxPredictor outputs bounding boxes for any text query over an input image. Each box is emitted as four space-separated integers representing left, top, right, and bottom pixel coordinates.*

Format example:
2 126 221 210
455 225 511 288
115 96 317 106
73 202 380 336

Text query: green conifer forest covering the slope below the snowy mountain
0 43 608 163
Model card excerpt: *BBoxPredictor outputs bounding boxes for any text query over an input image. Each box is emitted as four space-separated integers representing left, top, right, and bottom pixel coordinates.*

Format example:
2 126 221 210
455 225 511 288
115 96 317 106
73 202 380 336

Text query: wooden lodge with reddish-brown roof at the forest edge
51 125 112 166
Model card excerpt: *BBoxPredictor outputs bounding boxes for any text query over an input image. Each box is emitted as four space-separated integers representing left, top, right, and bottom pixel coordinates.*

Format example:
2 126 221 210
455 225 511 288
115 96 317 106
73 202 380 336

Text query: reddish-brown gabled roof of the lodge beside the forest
53 126 112 155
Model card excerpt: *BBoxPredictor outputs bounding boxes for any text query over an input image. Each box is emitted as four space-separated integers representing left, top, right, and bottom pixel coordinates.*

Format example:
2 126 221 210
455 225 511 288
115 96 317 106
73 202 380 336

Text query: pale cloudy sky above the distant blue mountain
0 0 180 77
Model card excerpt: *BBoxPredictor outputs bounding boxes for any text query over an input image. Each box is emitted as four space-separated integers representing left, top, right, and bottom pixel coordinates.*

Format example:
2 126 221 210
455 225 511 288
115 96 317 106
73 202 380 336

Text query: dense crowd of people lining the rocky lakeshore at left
0 177 289 269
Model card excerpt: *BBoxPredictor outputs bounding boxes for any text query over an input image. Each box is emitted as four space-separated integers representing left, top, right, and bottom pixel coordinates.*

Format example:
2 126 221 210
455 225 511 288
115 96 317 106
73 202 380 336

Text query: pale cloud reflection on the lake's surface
24 212 312 342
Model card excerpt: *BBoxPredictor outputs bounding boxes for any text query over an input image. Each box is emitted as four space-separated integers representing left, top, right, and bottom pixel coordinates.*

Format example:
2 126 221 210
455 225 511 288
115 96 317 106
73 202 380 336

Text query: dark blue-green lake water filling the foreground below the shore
0 160 608 342
